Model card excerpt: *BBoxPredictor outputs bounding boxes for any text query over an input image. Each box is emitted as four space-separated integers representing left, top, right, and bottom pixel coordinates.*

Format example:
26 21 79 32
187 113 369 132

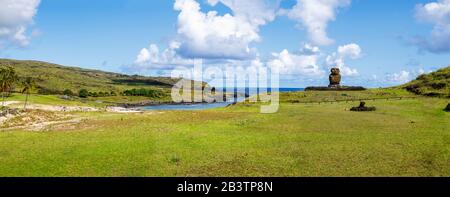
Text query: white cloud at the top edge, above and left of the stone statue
287 0 351 45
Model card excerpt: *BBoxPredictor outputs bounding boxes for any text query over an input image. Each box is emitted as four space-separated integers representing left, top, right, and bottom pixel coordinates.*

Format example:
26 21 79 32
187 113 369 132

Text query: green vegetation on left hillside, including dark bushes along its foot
0 59 195 103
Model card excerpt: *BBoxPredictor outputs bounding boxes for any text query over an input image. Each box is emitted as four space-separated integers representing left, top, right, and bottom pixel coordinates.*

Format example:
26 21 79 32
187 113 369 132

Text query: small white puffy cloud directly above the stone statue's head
326 43 362 76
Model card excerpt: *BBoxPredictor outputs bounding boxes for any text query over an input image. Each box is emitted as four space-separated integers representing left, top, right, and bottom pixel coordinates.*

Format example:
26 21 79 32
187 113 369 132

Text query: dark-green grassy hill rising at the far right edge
402 66 450 98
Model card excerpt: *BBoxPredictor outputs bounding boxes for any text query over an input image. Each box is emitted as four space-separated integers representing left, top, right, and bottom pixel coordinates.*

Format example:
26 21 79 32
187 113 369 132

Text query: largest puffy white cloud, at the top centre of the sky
174 0 275 59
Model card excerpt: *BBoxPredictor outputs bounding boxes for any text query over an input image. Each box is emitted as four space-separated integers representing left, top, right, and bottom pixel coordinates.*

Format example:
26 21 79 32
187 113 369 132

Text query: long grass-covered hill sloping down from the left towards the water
0 59 177 94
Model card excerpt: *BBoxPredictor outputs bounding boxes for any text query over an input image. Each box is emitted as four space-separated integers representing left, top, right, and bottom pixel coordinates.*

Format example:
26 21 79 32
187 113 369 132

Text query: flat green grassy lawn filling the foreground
0 92 450 176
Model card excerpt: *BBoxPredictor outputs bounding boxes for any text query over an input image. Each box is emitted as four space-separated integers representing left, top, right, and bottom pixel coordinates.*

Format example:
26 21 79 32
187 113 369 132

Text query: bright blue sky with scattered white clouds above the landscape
0 0 450 87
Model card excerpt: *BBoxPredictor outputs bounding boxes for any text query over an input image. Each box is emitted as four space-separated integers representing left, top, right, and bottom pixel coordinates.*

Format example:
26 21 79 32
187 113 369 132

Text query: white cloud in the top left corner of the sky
0 0 40 47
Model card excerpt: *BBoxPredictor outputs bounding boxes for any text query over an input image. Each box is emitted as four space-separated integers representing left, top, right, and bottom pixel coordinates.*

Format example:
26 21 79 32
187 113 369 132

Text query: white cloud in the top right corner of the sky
413 0 450 53
